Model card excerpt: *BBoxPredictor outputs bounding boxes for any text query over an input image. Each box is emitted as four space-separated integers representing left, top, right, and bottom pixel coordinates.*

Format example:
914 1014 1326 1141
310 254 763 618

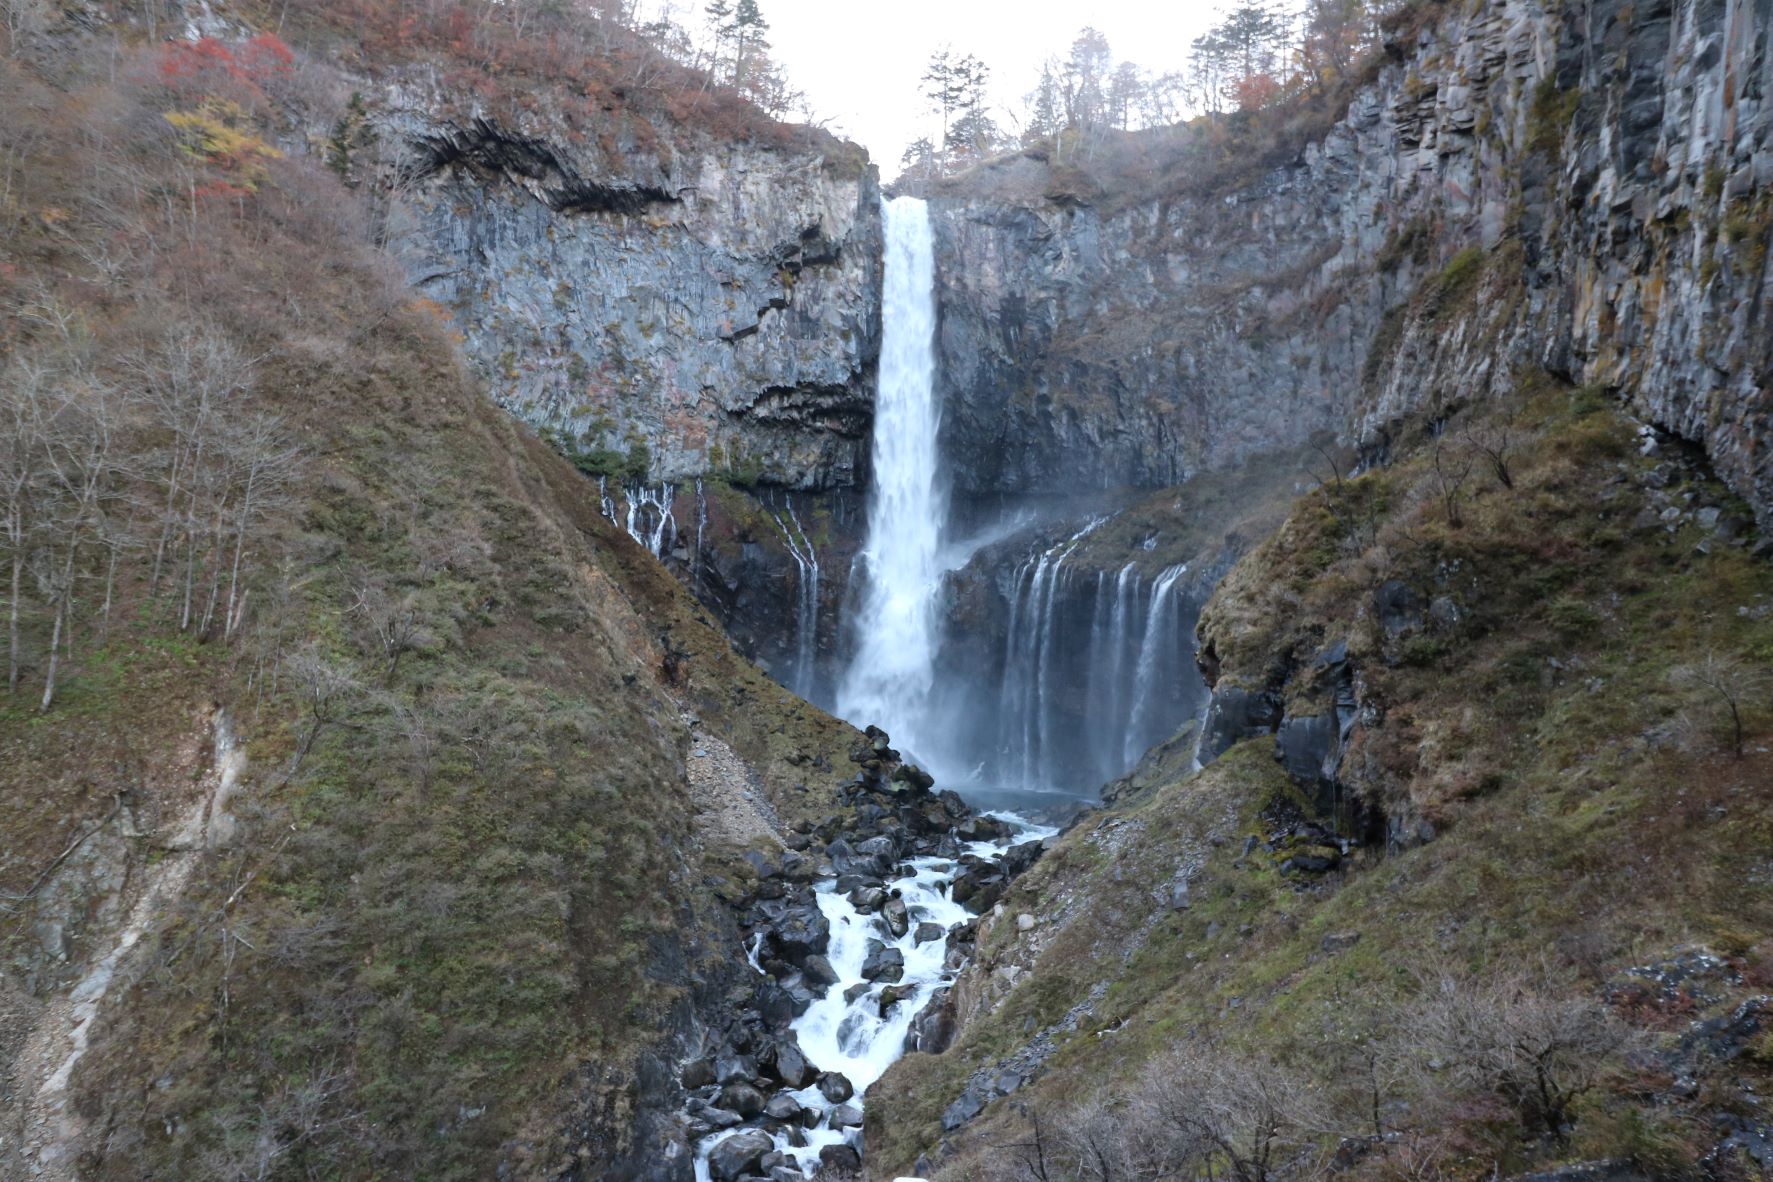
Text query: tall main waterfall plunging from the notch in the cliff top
837 197 947 750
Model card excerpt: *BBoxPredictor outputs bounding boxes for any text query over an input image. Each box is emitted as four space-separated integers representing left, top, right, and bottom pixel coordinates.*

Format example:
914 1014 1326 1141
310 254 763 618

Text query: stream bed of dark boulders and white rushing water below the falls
681 727 1053 1182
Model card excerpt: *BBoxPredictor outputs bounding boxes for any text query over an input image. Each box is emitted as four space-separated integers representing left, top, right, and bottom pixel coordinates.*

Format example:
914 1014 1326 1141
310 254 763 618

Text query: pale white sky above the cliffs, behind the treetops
648 0 1218 170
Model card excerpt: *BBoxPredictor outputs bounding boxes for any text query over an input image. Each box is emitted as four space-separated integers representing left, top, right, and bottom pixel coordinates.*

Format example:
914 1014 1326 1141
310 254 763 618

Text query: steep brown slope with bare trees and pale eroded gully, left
0 12 851 1178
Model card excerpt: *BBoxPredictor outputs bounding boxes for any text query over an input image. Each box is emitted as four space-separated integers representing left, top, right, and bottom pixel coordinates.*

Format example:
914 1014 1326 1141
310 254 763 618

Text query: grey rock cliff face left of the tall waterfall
383 99 881 489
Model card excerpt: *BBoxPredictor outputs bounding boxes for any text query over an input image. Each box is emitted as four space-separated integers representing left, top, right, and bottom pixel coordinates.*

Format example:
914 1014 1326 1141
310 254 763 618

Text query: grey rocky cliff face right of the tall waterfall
936 0 1773 517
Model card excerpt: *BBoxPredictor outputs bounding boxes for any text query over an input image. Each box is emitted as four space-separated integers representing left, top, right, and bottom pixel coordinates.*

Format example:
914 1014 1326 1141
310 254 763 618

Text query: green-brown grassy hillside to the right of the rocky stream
869 365 1773 1182
